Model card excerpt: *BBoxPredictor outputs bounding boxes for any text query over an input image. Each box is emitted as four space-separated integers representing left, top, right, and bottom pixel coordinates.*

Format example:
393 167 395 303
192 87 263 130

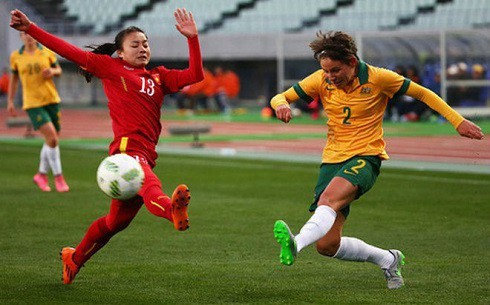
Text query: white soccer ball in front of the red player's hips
97 154 145 200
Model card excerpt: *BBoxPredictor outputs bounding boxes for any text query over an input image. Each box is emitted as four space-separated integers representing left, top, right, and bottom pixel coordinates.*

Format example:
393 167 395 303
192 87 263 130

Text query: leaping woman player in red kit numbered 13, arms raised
10 9 203 284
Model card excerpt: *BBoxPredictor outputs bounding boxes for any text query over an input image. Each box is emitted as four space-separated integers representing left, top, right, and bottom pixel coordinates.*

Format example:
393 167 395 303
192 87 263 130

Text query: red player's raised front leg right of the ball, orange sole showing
139 163 190 231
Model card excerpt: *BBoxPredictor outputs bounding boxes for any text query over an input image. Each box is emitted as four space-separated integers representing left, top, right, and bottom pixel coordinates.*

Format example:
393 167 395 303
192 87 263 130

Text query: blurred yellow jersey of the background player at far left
10 44 60 110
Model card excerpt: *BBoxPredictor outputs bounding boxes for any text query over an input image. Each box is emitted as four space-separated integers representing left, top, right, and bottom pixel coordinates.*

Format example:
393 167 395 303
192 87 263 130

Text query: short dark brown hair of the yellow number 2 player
310 31 359 63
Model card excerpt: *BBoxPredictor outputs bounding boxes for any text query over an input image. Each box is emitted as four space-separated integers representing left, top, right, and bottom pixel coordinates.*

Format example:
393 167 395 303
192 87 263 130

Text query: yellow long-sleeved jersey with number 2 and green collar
271 61 464 163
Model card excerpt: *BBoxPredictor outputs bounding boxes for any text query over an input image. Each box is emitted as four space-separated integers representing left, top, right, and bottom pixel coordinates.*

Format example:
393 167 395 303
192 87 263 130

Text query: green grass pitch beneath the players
0 142 490 305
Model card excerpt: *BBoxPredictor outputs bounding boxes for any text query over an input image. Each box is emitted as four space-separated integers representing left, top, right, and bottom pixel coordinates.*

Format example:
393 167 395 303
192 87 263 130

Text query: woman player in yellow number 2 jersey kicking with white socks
271 31 483 289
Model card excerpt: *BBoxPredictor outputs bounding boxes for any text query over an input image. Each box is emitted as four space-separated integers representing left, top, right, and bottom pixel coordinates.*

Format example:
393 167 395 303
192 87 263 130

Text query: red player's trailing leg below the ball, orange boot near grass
61 197 143 284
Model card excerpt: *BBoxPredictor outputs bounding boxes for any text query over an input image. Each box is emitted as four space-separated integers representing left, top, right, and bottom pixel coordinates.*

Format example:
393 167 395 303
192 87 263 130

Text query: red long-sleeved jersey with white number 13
27 24 204 166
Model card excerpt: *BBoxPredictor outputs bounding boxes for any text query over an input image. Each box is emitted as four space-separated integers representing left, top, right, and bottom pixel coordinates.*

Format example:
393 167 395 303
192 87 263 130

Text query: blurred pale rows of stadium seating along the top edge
10 0 490 35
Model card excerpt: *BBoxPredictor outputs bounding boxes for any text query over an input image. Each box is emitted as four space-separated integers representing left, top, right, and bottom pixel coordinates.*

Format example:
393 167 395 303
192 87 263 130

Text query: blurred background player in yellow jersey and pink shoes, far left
7 32 69 192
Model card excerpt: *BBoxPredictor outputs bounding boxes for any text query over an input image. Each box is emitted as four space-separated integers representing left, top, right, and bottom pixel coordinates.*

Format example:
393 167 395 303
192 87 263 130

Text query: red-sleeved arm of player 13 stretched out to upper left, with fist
10 10 88 67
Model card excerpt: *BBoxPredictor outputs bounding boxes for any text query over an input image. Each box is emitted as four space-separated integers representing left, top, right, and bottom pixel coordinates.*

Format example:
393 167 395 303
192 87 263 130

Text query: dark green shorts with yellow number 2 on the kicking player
310 156 381 218
